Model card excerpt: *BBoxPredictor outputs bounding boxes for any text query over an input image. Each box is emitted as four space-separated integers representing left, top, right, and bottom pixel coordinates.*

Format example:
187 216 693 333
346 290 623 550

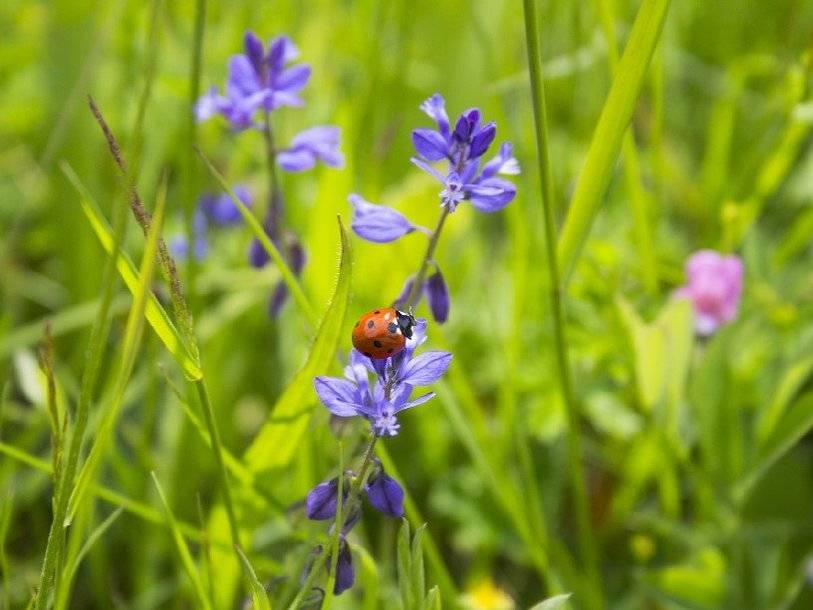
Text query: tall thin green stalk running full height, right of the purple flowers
523 0 601 606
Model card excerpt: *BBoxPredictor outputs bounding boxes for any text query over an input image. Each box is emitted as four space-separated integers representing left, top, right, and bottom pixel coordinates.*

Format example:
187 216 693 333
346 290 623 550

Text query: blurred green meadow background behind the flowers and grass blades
0 0 813 609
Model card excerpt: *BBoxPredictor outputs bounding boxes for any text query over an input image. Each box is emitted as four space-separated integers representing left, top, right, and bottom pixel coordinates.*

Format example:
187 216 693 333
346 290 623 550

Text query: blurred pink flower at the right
675 250 743 337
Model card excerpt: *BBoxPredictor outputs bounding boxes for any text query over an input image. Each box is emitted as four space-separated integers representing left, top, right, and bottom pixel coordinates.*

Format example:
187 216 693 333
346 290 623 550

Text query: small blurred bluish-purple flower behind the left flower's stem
170 185 252 260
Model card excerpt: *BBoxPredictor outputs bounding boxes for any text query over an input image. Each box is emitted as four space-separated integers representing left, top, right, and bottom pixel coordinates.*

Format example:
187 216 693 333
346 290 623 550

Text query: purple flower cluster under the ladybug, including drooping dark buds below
305 319 452 594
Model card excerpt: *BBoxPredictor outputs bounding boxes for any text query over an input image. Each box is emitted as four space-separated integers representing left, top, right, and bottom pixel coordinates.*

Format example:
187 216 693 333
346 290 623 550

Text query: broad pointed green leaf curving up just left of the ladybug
245 219 352 472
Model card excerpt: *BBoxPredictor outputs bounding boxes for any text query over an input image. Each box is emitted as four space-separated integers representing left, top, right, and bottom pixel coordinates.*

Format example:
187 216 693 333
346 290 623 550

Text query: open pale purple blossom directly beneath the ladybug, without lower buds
314 319 452 436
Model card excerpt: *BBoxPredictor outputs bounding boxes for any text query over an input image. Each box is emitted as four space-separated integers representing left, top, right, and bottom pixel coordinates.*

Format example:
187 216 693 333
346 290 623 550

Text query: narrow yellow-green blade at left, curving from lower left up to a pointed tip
65 182 166 524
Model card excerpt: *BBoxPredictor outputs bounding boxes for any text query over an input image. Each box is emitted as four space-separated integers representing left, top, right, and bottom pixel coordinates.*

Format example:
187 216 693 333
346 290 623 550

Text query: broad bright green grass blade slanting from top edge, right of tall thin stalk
558 0 669 279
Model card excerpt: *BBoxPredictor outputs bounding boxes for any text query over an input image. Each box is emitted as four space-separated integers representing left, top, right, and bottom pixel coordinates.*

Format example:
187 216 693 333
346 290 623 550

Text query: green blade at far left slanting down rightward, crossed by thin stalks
61 163 203 381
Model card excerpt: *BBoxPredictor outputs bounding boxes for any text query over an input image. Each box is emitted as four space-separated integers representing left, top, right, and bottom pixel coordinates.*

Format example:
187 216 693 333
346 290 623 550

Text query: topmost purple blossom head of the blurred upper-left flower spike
195 31 310 130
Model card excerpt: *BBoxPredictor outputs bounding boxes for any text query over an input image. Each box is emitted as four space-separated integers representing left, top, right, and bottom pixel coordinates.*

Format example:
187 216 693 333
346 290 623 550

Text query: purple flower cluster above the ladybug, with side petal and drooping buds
349 93 520 322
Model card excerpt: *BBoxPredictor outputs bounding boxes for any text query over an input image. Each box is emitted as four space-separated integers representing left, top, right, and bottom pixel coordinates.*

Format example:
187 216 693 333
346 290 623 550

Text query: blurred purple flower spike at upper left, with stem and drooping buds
195 31 344 316
